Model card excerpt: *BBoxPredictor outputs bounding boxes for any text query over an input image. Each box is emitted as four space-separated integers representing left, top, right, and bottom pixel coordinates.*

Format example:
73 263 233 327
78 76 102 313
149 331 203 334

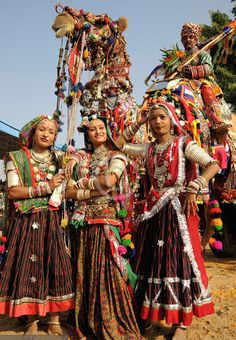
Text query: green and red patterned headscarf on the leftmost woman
19 111 62 147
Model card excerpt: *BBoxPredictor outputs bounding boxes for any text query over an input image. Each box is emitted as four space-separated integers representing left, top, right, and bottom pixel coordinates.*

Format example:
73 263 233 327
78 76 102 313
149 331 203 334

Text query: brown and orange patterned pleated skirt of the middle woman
76 224 140 340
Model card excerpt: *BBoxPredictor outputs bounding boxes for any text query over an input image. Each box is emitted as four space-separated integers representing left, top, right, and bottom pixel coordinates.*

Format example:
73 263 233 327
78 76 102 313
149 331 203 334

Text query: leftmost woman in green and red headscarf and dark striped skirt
0 115 74 334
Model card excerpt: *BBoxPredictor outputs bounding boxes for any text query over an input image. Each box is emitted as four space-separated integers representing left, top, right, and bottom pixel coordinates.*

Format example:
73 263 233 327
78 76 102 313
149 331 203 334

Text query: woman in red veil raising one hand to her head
116 101 219 339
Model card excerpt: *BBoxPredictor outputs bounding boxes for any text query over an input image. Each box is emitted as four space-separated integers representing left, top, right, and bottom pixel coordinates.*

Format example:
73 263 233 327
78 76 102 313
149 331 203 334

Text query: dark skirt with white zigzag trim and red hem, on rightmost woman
133 200 214 326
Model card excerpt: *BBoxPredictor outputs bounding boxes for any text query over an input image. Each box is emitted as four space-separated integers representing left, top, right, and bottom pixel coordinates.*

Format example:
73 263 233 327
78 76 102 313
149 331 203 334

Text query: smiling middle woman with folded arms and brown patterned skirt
66 117 140 339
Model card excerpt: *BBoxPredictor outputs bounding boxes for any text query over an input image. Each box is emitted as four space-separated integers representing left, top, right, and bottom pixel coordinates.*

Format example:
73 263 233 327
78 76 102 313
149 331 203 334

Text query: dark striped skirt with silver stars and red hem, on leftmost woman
0 211 74 317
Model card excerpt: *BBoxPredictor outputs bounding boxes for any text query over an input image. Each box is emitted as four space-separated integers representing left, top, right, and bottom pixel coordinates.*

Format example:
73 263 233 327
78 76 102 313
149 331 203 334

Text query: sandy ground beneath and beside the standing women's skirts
0 250 236 340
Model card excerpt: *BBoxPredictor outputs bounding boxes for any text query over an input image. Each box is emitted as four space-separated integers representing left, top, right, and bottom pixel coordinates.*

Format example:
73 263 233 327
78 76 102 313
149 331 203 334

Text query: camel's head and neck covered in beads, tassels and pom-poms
52 5 142 142
